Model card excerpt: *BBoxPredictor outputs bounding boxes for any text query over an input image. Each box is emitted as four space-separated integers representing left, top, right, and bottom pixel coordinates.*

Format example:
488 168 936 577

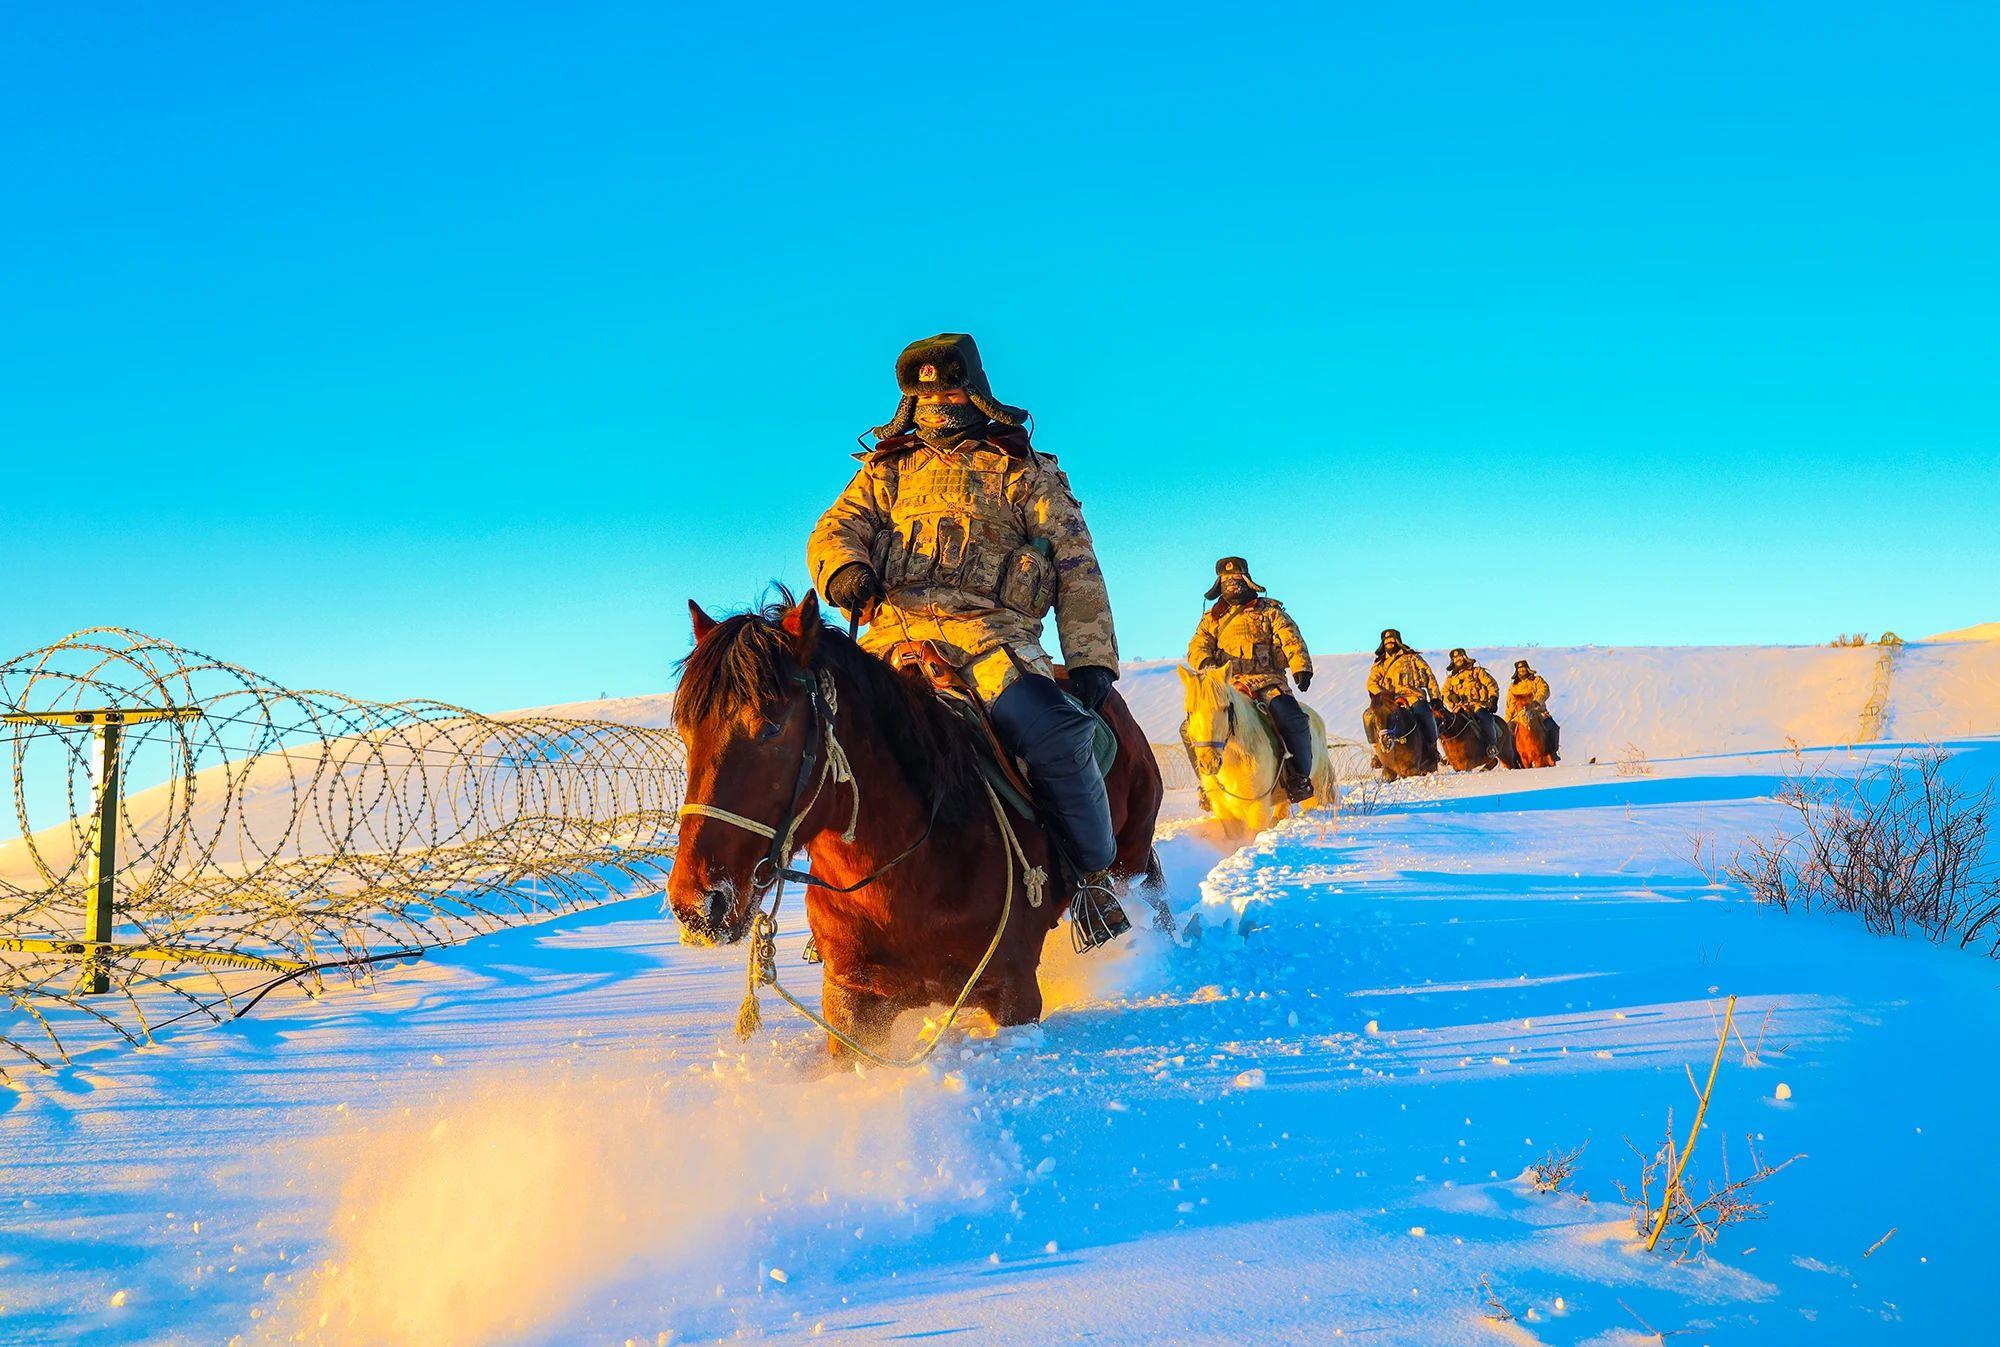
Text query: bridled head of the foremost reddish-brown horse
666 592 824 945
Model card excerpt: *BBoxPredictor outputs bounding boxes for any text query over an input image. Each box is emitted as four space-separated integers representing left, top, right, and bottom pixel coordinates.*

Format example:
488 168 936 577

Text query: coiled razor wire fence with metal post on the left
0 628 686 1075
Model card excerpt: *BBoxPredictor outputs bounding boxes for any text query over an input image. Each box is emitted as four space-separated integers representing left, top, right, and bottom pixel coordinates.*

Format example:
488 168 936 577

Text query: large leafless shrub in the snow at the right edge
1726 747 2000 955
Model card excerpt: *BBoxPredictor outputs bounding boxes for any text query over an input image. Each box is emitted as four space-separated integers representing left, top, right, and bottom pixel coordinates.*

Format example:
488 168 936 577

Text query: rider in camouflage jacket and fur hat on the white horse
1188 556 1312 809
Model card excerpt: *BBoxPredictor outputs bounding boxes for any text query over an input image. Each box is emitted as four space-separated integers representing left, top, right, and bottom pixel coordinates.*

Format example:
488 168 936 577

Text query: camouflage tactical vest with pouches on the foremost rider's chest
870 450 1056 620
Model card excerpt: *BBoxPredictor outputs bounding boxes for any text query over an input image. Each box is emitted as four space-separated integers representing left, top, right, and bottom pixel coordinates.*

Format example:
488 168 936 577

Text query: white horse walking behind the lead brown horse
1178 666 1338 833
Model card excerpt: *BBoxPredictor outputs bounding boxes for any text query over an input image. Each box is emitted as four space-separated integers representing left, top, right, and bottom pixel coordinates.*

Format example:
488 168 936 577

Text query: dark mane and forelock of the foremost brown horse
674 588 982 823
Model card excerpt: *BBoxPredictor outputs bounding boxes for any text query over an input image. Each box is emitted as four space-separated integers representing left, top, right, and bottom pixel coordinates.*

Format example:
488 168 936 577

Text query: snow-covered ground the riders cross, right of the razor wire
0 646 2000 1345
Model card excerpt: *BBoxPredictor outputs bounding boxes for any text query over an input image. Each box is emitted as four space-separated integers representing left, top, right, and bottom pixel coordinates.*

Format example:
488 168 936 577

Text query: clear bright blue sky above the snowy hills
0 0 2000 709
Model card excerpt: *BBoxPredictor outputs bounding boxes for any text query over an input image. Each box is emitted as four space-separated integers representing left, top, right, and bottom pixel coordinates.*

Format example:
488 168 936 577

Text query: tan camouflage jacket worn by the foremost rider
806 426 1118 699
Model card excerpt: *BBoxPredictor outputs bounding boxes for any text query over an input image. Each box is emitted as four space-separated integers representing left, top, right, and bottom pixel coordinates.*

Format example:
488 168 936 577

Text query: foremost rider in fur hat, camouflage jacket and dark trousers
806 332 1128 939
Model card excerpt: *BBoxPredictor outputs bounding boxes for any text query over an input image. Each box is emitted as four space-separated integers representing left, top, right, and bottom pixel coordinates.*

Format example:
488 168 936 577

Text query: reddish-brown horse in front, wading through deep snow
666 594 1162 1057
